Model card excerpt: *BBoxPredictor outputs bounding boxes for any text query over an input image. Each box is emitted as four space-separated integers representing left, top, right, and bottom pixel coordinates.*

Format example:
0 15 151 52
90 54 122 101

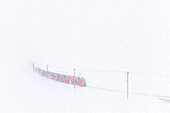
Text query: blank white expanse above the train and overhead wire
0 0 170 73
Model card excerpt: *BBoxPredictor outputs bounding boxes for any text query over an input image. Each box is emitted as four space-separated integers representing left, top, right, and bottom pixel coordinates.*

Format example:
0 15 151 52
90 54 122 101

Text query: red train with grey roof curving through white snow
34 68 86 87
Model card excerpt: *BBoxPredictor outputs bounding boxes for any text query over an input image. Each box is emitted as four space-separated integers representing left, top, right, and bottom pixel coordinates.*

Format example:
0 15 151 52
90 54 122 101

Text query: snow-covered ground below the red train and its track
1 59 170 113
